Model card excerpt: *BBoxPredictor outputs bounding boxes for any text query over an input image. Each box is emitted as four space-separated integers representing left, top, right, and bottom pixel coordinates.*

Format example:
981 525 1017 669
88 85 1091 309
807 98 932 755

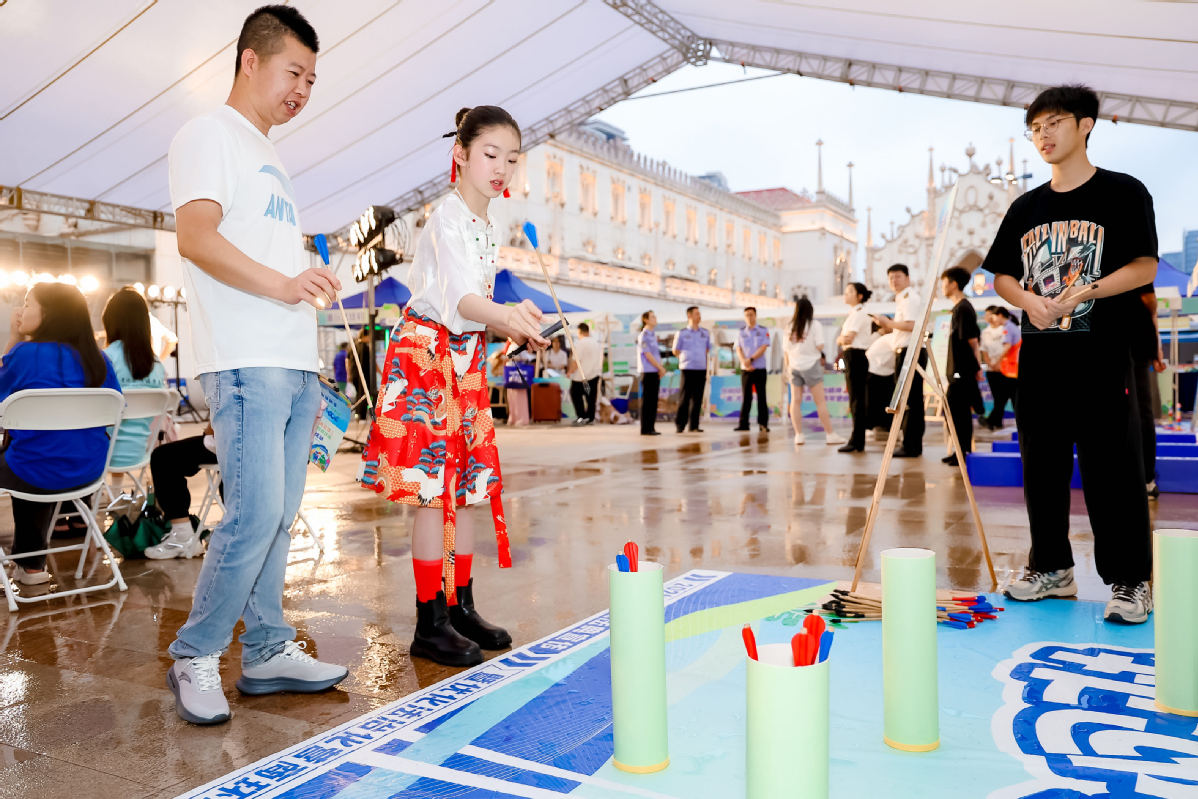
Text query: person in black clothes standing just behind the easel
940 266 986 466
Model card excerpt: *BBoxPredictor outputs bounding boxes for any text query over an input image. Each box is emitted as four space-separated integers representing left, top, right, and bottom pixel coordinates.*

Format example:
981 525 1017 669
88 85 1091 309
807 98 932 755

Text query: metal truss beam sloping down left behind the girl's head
354 50 686 232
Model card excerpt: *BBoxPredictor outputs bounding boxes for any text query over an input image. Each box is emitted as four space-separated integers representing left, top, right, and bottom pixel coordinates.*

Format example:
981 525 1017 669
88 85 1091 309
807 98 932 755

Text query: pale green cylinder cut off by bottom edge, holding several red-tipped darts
745 643 828 799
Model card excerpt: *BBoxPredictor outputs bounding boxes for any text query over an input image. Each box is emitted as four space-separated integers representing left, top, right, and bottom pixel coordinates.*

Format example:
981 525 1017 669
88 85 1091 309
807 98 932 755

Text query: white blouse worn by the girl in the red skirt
407 192 498 334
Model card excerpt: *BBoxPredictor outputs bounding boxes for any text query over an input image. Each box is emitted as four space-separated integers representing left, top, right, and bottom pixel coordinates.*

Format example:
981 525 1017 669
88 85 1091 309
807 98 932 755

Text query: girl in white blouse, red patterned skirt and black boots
362 105 549 666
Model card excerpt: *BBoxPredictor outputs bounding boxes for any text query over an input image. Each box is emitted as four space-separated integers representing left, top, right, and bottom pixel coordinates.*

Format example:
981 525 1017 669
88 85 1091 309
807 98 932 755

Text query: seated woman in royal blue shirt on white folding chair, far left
0 283 121 586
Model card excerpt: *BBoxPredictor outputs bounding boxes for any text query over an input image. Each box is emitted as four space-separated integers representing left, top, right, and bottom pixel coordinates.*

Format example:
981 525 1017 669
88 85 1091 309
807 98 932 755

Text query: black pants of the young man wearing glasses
1015 346 1152 585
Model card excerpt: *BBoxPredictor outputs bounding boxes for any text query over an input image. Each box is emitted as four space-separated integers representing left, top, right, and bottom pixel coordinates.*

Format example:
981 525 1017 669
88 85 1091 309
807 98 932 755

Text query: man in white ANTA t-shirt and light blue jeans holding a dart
167 6 347 724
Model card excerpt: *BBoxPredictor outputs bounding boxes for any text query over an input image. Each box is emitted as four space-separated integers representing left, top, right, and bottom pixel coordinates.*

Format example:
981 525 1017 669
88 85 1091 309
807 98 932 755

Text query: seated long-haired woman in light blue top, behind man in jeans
101 287 167 470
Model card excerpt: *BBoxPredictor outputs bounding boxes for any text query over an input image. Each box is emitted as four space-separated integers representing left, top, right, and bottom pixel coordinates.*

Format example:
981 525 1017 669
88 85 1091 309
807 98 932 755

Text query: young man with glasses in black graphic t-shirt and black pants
982 86 1157 623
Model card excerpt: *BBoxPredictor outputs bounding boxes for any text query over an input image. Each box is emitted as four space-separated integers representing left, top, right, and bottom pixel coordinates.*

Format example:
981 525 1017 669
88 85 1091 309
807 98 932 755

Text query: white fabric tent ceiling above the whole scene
0 0 1198 231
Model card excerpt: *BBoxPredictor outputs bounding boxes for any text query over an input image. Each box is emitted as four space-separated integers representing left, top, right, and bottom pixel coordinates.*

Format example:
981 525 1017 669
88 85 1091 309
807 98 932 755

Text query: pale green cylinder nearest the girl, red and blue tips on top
607 561 670 774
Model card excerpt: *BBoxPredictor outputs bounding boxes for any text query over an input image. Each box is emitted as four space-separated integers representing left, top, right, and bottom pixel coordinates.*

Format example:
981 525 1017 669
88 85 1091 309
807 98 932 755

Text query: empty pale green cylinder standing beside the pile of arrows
882 547 940 752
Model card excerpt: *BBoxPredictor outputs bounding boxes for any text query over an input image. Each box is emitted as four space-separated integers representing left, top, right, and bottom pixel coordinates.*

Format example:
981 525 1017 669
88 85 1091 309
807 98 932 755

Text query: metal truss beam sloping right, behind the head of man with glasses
710 40 1198 131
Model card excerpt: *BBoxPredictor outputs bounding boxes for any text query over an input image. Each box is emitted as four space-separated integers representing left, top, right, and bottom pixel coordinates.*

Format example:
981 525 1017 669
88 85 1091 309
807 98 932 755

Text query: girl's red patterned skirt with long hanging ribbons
362 309 512 604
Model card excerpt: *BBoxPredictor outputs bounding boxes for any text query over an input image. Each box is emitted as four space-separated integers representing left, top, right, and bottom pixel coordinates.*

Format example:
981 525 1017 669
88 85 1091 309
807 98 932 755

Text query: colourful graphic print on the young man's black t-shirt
1019 219 1105 331
